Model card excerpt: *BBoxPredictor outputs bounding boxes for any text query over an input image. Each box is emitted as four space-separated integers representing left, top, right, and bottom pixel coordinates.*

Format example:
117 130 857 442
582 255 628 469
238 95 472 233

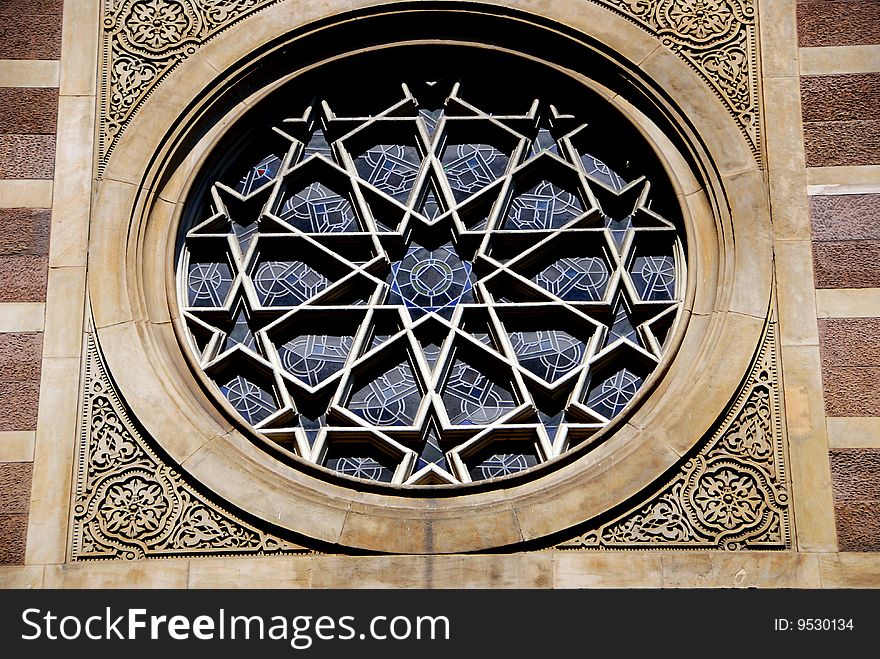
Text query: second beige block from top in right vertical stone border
764 78 810 240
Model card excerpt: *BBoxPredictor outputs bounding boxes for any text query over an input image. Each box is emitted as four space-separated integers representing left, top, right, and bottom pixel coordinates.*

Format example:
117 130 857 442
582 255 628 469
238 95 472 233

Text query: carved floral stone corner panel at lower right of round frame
558 324 791 550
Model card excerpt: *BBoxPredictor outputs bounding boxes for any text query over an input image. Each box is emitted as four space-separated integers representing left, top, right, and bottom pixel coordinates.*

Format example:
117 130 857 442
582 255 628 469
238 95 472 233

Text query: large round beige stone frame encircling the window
88 3 772 553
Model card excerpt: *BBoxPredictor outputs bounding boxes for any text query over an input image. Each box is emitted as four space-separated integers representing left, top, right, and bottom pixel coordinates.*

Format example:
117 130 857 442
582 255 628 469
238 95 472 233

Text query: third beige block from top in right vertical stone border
776 240 819 345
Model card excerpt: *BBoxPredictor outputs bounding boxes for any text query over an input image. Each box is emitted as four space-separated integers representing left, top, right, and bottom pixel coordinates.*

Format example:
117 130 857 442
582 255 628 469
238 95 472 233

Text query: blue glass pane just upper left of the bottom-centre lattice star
348 362 422 426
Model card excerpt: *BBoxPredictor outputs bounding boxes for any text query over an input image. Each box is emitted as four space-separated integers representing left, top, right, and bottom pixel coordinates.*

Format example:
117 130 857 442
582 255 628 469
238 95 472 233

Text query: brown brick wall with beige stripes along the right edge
797 0 880 551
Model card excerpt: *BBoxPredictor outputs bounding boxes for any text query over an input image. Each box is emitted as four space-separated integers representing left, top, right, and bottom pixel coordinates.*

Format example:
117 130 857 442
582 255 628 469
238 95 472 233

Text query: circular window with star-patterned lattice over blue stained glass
177 45 685 485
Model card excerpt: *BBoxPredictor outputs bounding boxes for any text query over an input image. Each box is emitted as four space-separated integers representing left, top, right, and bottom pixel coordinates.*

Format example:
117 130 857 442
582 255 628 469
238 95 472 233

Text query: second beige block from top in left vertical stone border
49 96 95 267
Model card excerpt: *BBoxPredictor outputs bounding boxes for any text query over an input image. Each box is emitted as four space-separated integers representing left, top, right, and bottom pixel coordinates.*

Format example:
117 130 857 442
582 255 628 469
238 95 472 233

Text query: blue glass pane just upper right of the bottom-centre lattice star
443 361 516 425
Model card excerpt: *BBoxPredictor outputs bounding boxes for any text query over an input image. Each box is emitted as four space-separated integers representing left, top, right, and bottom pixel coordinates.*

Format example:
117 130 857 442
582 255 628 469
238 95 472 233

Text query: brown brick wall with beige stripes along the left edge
0 0 63 565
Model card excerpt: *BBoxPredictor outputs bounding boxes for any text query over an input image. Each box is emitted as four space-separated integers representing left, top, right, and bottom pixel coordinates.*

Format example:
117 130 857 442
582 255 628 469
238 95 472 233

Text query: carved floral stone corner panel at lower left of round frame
71 328 306 561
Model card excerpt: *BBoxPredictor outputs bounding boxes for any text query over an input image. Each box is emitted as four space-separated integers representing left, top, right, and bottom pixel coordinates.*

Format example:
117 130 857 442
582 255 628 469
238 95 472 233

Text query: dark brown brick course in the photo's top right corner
797 0 880 47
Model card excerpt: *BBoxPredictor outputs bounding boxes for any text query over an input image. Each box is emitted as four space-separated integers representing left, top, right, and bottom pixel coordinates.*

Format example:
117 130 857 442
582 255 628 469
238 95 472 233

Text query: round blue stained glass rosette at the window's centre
389 245 473 315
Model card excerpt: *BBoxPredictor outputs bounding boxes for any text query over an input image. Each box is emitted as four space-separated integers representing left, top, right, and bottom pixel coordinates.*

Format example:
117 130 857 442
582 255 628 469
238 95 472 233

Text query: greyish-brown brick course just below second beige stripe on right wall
810 194 880 241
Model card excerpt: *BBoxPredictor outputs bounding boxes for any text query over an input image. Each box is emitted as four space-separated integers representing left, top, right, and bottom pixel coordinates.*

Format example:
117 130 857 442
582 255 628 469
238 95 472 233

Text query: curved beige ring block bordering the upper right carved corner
641 48 756 176
